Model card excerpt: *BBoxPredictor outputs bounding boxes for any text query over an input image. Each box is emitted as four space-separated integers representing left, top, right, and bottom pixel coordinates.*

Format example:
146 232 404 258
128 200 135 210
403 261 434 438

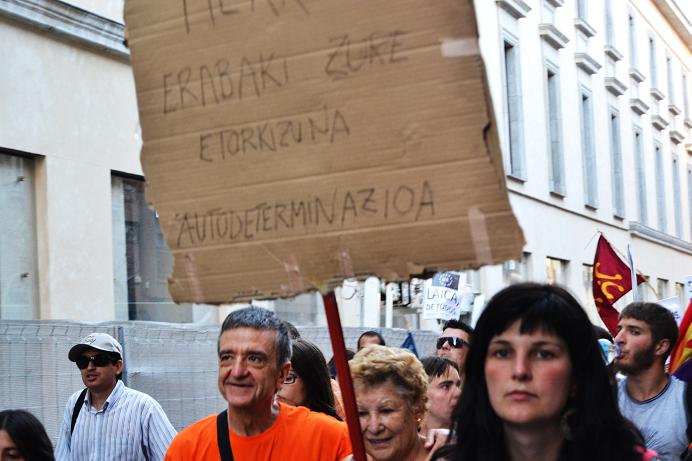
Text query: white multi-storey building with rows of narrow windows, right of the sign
476 0 692 320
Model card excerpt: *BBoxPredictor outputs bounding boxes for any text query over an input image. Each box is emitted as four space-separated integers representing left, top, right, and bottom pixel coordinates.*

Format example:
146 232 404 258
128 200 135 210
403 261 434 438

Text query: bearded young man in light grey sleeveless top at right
615 302 690 461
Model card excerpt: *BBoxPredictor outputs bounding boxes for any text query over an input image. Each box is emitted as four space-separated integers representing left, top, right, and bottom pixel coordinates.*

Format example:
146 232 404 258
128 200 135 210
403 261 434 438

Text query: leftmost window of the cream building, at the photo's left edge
0 151 39 320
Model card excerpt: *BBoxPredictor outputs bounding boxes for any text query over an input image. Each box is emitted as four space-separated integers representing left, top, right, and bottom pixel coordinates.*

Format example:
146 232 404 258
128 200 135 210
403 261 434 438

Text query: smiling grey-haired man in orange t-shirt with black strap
165 307 351 461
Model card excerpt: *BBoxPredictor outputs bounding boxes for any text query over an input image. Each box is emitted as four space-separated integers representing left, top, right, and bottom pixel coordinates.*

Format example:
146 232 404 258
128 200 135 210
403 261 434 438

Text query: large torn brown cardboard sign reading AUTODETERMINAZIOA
125 0 524 303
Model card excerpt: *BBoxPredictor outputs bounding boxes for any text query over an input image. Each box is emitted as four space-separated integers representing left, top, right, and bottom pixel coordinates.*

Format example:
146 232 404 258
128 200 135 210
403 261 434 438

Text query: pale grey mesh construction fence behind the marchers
0 320 437 443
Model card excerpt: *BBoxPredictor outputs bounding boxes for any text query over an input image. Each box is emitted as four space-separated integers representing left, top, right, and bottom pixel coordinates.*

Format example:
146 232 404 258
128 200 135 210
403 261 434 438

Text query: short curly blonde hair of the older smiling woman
349 345 428 412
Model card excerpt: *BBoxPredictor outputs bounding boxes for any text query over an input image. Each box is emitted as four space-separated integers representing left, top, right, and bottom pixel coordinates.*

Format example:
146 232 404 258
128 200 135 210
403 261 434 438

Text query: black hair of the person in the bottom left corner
0 410 55 461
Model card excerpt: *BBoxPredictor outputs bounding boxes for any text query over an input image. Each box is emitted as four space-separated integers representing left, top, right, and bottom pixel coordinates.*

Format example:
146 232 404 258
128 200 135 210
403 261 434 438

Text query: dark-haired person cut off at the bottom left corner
0 410 55 461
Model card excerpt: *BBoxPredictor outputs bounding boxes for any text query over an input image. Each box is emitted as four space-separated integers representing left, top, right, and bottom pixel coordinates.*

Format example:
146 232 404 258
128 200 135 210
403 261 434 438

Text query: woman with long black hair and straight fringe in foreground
436 283 652 461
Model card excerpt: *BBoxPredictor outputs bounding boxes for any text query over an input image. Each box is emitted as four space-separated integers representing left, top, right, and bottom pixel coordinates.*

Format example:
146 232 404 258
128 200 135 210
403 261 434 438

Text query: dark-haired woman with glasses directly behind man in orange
277 339 341 420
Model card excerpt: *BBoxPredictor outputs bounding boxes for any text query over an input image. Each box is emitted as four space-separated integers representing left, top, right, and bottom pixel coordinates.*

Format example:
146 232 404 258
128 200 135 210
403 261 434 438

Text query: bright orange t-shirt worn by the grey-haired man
165 403 351 461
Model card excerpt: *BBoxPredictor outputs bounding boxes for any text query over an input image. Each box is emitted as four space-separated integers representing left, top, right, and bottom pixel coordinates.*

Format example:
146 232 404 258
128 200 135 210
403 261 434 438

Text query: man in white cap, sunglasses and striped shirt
55 333 176 461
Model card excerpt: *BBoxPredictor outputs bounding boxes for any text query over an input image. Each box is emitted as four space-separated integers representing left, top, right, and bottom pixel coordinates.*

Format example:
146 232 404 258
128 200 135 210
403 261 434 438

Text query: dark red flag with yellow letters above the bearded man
592 235 644 336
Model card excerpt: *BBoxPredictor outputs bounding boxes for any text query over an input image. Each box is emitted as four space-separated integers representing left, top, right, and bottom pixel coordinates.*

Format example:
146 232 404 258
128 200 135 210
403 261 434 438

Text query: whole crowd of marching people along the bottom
0 283 692 461
